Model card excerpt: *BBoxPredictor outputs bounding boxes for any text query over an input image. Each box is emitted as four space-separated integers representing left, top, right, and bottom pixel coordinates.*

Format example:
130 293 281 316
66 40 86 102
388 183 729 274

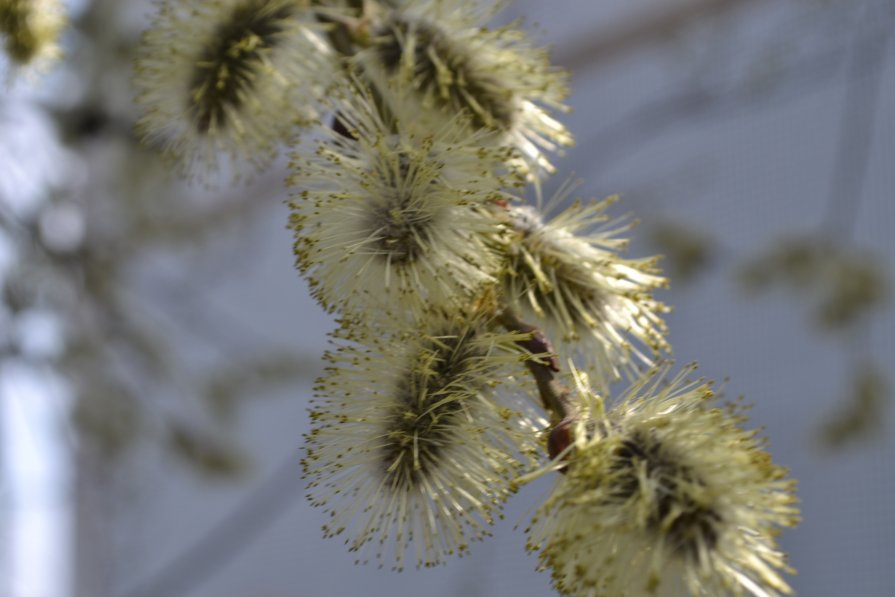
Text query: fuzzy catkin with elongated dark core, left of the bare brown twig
303 317 537 570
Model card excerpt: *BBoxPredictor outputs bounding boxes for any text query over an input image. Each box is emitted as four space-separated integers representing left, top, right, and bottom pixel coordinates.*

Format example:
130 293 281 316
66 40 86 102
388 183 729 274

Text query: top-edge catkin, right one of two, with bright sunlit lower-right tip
359 0 573 175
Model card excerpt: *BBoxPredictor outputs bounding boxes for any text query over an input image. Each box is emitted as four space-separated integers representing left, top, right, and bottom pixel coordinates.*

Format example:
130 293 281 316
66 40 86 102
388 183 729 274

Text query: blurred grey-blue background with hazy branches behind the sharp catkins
0 0 895 597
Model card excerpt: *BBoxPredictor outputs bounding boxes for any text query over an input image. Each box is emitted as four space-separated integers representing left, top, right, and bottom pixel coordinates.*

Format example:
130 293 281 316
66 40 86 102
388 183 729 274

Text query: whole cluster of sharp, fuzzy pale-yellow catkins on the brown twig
135 0 798 597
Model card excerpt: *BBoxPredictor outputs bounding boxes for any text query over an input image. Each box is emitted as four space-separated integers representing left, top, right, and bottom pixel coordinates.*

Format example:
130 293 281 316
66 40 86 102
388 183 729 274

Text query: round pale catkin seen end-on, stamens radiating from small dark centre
289 86 514 317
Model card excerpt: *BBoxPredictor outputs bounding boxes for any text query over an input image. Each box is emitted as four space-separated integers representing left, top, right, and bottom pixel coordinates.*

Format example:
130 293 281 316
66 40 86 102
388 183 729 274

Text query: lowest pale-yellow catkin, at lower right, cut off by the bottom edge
529 367 798 597
